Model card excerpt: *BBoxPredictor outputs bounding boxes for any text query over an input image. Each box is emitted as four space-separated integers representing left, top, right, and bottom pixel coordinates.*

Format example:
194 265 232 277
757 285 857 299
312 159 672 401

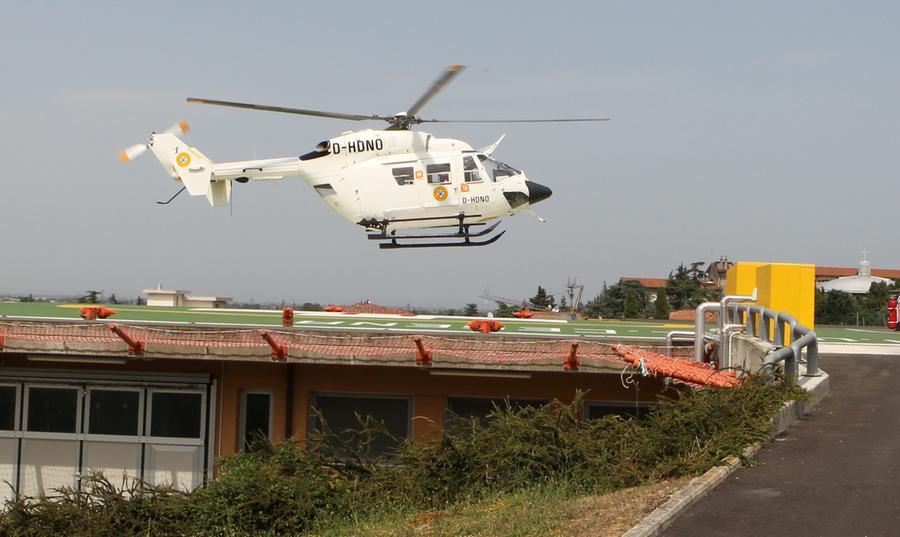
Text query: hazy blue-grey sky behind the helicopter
0 1 900 307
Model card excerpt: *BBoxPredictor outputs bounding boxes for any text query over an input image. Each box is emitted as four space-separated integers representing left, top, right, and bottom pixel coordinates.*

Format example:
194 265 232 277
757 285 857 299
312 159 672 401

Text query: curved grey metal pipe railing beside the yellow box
666 290 819 379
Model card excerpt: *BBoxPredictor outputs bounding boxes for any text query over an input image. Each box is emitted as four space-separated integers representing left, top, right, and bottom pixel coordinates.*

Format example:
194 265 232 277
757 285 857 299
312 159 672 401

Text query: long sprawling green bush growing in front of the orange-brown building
0 377 802 536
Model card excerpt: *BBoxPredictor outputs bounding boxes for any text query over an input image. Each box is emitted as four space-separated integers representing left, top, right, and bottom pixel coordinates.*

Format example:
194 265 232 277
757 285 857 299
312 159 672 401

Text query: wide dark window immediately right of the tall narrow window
312 395 410 456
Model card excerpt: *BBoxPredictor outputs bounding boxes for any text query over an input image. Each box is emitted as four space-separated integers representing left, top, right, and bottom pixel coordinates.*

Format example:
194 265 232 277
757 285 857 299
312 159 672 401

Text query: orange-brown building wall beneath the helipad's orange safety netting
0 354 665 488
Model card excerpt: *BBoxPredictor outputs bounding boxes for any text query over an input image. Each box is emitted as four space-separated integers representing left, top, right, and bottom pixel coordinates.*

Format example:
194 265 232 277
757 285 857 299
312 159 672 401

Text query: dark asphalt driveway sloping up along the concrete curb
662 356 900 537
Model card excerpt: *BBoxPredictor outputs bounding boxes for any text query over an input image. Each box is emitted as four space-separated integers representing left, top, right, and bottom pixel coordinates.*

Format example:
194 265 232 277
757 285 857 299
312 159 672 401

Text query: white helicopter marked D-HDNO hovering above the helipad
119 65 608 249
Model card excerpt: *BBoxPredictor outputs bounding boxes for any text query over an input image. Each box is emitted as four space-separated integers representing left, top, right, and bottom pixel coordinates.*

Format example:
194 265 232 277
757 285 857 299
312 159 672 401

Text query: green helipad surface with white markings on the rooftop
0 302 900 346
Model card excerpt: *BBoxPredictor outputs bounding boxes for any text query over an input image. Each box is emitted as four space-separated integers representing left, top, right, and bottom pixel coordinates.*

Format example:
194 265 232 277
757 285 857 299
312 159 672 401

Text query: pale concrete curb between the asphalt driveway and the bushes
622 370 830 537
